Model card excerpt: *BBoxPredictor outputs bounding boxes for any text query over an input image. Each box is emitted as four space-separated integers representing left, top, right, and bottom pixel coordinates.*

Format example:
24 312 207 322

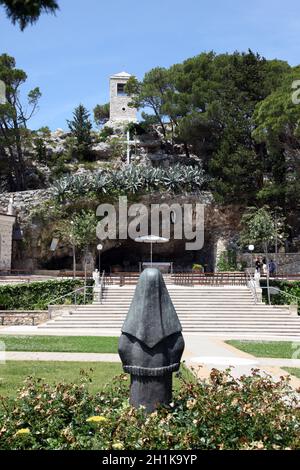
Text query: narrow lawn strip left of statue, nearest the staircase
0 335 118 353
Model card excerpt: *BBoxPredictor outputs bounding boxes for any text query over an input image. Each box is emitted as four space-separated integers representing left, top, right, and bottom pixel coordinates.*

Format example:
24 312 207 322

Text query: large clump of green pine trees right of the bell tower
126 50 300 207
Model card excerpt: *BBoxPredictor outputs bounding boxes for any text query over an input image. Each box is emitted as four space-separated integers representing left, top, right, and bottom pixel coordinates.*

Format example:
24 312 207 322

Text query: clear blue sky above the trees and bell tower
0 0 300 129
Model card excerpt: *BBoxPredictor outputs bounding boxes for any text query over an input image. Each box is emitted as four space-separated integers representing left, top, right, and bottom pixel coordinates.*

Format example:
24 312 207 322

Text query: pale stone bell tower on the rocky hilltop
108 72 137 125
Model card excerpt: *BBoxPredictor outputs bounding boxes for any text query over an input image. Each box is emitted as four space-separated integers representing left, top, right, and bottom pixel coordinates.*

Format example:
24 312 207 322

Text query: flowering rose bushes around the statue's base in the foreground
0 370 300 450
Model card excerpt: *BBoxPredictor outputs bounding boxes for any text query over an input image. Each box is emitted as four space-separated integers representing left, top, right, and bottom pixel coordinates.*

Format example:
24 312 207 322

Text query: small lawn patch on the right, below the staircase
226 340 300 359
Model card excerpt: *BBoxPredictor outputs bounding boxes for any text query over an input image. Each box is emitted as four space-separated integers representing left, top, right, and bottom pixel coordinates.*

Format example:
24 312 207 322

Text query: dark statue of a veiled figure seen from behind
119 268 184 413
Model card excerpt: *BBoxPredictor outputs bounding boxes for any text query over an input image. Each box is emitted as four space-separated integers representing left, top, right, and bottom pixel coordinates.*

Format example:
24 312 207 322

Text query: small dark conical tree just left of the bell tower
67 104 93 159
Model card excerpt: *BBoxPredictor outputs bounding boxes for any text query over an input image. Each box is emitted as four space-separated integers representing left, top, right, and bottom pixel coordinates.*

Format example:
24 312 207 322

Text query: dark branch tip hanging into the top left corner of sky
0 0 59 31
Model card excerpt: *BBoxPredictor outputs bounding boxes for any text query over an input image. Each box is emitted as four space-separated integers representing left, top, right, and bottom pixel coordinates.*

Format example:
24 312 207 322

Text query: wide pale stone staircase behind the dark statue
39 284 300 338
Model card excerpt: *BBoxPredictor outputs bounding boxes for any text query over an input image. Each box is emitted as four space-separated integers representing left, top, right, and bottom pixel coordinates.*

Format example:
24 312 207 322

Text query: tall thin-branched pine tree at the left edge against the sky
0 54 41 191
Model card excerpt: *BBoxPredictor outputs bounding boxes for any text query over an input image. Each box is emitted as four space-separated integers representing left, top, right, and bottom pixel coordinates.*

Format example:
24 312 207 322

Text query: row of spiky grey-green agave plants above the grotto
52 164 207 203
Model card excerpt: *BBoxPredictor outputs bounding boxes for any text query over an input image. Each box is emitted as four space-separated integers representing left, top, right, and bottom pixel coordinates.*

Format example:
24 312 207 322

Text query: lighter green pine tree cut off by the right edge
253 67 300 209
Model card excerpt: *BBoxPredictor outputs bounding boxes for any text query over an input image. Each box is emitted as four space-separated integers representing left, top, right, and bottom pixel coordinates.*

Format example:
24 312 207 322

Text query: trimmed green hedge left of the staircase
0 279 83 310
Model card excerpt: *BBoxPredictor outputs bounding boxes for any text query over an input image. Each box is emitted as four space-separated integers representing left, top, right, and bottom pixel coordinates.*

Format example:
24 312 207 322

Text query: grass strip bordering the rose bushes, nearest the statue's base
0 361 193 398
